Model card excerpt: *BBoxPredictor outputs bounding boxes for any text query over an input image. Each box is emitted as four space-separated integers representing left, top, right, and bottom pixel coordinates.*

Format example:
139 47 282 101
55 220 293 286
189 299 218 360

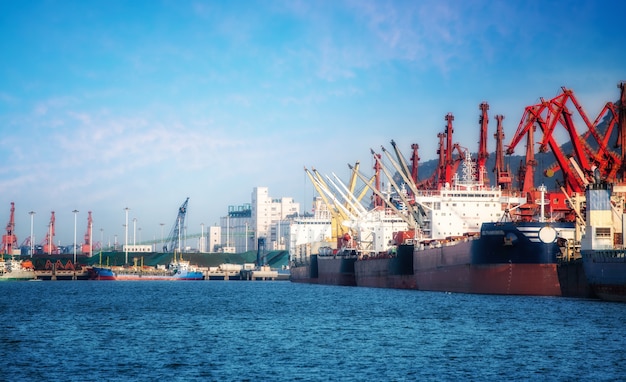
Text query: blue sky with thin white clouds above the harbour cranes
0 0 626 245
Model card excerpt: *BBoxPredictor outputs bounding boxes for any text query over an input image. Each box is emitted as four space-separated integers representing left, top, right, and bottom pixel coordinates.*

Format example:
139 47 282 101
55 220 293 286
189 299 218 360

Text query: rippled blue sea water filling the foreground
0 281 626 381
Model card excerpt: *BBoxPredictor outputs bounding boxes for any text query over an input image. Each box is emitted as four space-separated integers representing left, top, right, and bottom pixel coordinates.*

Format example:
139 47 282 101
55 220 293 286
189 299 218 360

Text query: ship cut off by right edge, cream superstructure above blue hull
581 183 626 302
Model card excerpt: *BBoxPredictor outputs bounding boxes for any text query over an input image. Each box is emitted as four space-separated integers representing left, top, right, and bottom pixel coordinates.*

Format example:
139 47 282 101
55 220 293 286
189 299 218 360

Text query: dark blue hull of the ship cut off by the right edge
582 249 626 302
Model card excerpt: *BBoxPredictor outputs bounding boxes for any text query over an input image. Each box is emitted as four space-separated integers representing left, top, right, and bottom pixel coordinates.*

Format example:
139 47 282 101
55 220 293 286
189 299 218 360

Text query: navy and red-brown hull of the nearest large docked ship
414 222 589 297
